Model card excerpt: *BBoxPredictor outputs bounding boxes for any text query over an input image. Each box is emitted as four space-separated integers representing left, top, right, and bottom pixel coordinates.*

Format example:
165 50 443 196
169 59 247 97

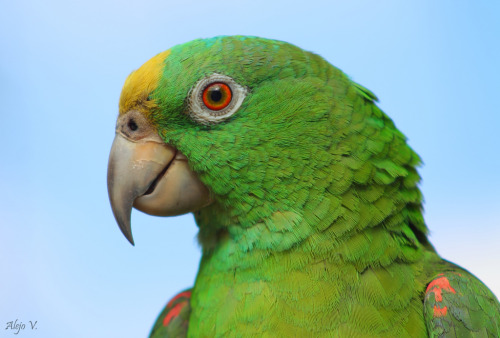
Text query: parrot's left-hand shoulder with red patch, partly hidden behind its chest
149 289 191 338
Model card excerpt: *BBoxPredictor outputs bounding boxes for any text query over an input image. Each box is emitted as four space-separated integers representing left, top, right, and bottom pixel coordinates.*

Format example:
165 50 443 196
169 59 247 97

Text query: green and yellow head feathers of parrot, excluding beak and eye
121 36 427 255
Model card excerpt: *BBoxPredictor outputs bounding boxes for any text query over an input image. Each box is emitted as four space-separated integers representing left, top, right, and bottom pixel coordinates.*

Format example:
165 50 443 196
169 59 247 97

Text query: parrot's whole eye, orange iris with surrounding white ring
188 73 247 125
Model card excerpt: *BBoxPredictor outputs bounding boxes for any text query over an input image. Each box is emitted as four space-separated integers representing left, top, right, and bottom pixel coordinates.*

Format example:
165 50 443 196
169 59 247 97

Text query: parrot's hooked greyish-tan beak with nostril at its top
108 111 213 245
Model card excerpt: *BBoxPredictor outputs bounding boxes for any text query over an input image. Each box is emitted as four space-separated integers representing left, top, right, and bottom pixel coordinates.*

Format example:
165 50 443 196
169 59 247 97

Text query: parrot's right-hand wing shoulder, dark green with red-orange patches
424 263 500 337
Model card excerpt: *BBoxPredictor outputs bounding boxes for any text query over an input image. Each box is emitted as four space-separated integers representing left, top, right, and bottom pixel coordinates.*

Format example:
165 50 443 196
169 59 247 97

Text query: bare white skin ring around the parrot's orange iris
188 73 248 125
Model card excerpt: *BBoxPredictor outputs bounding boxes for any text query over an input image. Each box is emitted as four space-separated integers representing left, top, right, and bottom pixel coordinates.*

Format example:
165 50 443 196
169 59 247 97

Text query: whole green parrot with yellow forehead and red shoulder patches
108 36 500 337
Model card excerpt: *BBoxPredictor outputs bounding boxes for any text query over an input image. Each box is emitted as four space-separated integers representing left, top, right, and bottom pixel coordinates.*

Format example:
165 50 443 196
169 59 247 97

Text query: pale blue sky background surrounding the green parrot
0 0 500 337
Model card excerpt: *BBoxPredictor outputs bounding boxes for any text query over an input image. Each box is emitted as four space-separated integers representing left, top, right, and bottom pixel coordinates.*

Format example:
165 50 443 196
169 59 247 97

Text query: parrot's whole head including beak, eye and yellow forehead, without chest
108 36 426 248
